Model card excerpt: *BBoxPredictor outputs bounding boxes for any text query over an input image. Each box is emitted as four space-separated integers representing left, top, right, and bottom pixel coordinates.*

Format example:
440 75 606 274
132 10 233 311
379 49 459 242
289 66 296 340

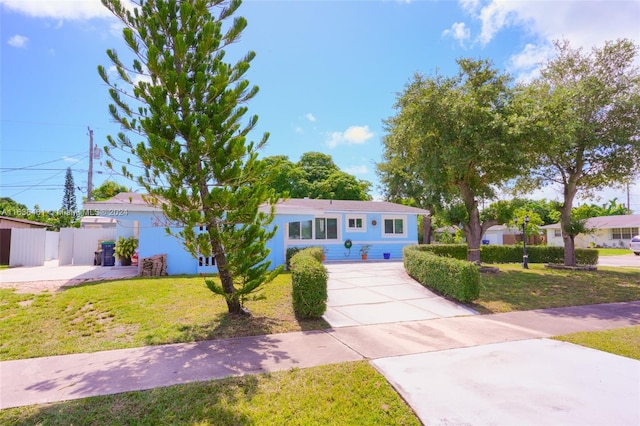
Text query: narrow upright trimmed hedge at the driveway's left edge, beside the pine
290 247 329 318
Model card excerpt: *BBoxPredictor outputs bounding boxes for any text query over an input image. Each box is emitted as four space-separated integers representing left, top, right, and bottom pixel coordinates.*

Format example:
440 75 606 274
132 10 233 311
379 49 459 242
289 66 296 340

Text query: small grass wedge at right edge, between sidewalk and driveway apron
555 325 640 360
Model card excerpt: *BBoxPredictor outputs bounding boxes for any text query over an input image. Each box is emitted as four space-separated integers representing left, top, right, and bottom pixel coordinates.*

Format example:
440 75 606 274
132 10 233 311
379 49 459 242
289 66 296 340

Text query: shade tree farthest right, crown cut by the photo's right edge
519 40 640 266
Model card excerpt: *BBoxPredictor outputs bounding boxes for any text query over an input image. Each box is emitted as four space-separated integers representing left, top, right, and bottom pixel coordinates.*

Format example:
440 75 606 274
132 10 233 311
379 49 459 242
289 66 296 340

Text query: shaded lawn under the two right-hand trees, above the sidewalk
469 264 640 313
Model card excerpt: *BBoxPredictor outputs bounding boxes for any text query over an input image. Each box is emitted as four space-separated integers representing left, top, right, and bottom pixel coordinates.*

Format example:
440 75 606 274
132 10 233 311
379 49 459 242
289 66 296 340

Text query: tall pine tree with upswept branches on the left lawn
99 0 278 313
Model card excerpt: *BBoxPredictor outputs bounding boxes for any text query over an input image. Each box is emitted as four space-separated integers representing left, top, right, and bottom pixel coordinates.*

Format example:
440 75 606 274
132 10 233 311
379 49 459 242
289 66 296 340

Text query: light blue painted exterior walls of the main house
92 201 418 275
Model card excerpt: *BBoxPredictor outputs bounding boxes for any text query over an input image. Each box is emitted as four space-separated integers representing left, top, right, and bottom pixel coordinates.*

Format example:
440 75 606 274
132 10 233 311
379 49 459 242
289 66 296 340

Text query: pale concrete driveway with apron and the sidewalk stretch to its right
324 262 640 426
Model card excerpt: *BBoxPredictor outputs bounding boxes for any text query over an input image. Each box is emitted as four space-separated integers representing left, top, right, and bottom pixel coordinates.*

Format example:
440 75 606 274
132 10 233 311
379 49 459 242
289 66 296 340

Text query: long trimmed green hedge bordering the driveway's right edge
403 246 480 302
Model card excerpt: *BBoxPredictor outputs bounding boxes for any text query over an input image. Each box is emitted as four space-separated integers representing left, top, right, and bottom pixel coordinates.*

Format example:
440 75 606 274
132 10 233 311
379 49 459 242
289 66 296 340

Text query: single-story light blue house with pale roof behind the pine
84 193 429 275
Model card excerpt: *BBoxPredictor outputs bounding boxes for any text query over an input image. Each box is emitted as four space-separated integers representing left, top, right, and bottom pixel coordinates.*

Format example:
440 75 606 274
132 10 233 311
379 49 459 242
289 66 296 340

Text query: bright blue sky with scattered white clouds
0 0 640 213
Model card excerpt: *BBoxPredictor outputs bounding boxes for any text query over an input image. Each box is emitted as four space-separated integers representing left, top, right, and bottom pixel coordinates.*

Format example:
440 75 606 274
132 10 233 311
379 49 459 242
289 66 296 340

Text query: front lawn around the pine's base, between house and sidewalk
0 274 328 360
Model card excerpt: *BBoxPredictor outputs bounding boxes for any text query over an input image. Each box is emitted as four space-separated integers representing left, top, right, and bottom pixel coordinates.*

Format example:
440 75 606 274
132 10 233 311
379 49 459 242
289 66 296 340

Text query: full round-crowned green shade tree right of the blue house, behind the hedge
379 59 525 262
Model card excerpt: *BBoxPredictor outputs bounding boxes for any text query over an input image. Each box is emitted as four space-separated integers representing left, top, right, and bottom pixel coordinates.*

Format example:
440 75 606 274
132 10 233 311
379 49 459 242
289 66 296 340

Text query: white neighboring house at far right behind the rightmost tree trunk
540 215 640 248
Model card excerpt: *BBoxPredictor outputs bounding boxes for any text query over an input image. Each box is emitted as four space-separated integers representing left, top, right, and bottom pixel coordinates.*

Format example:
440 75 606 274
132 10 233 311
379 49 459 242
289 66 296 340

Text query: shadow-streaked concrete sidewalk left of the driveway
2 322 314 412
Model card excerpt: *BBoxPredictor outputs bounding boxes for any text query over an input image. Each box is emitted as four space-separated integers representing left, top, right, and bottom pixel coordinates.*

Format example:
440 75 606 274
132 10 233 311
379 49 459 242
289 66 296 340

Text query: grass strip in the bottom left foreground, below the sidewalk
0 361 420 426
